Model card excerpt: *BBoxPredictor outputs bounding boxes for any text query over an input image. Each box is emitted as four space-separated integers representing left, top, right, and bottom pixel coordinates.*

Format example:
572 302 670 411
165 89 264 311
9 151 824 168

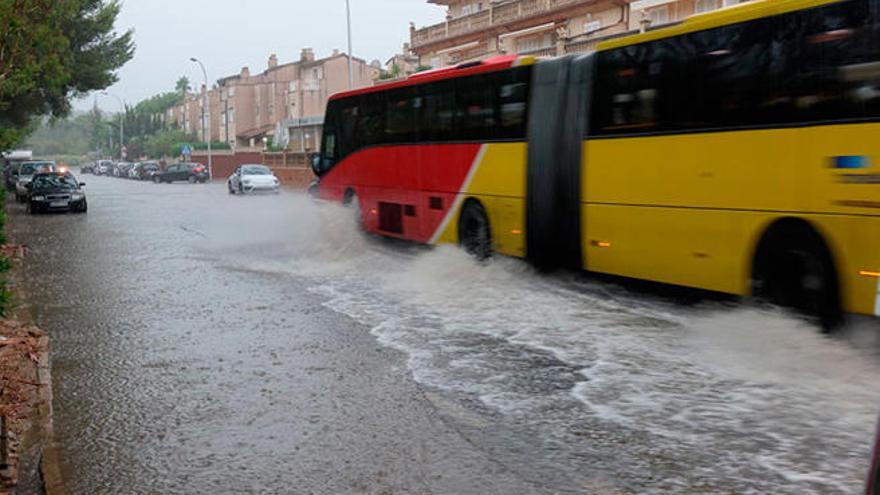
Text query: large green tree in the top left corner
0 0 134 149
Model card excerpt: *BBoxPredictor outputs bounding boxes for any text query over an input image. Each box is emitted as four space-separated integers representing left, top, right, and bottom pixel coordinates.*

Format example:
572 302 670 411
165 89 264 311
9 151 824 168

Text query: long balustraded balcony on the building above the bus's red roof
411 0 596 48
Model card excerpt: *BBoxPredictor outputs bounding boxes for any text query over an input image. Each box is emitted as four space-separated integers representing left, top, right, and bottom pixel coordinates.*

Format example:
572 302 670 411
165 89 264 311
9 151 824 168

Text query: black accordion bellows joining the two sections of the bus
526 55 593 268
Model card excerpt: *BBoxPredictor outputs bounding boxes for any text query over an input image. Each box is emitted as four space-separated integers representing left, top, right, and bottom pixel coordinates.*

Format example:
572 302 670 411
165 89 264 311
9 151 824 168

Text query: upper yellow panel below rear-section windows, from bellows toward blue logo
581 129 801 210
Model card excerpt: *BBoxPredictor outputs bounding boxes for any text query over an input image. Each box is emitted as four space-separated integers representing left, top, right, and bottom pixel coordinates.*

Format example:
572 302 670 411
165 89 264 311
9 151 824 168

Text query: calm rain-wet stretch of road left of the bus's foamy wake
10 175 543 494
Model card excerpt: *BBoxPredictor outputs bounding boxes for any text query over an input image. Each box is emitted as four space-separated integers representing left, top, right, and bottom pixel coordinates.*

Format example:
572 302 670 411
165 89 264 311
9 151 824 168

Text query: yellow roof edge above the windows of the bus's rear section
598 0 843 51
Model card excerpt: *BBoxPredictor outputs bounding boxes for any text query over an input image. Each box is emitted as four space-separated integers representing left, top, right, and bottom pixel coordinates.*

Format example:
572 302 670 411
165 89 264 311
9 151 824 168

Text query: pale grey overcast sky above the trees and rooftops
75 0 445 111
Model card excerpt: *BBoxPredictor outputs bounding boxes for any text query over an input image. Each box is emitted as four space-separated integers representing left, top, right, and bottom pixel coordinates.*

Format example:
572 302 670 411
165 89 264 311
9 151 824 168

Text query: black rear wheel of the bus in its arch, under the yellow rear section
752 218 843 331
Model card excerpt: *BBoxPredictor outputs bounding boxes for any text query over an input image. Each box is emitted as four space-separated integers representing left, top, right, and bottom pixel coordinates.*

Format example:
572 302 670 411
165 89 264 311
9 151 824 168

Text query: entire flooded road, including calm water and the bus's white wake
9 176 880 494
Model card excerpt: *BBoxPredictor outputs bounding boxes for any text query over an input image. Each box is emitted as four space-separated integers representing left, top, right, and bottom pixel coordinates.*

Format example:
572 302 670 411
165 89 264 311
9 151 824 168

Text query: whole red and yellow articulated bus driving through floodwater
313 0 880 325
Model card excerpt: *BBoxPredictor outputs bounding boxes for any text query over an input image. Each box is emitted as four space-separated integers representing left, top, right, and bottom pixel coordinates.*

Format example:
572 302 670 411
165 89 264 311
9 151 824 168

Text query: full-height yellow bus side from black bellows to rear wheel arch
582 130 802 294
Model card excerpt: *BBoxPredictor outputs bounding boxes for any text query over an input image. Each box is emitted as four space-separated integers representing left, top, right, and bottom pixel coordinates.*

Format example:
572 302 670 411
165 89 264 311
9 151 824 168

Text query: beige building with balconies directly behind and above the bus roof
410 0 747 68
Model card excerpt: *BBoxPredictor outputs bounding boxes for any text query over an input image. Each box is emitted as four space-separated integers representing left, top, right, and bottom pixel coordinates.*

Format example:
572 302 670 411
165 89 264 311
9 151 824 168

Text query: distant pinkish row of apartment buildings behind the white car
210 48 380 150
